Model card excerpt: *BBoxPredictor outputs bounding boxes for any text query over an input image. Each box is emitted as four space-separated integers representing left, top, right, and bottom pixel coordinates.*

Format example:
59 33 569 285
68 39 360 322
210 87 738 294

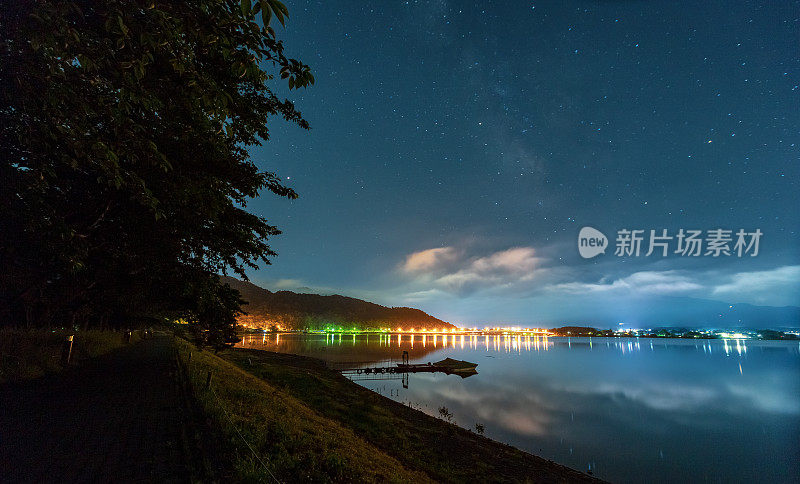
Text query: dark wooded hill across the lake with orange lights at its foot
222 277 455 329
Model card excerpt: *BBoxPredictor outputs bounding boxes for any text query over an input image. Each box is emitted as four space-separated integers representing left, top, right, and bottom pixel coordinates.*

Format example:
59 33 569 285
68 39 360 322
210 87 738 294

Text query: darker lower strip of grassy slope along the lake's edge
220 349 593 482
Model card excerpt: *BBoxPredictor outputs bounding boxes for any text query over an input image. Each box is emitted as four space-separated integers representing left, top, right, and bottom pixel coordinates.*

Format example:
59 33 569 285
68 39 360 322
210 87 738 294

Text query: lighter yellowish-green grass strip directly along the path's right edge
177 339 430 482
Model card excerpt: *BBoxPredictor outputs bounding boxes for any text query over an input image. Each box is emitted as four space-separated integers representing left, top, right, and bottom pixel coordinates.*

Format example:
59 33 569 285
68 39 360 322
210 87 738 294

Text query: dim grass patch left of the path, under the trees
0 329 140 383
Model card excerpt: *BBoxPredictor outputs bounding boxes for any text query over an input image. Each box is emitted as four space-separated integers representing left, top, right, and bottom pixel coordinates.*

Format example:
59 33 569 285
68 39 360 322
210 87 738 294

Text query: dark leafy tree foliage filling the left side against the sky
0 0 314 345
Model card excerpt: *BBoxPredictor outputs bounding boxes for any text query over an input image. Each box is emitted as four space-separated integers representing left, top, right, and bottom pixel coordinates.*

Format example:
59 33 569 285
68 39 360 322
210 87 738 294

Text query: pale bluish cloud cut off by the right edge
712 265 800 305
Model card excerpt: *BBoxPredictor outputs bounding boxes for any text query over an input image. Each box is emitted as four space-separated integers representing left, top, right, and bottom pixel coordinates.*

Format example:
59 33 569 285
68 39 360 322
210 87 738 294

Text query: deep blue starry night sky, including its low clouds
241 0 800 326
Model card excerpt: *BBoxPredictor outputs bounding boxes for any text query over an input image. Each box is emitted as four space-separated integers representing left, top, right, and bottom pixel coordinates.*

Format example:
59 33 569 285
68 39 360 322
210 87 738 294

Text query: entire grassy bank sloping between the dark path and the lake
179 342 593 482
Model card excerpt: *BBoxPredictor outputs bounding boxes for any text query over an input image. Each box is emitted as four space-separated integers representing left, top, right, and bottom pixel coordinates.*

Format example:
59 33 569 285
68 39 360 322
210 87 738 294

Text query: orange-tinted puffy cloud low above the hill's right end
402 247 541 294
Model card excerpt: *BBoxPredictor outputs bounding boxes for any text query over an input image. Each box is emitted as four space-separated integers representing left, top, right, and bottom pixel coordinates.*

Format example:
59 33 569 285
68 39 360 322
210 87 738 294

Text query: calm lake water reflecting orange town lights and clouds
242 334 800 482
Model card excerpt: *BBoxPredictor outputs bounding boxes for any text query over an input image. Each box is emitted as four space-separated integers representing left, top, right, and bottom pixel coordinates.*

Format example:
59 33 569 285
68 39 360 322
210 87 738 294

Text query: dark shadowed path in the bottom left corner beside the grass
0 335 201 482
